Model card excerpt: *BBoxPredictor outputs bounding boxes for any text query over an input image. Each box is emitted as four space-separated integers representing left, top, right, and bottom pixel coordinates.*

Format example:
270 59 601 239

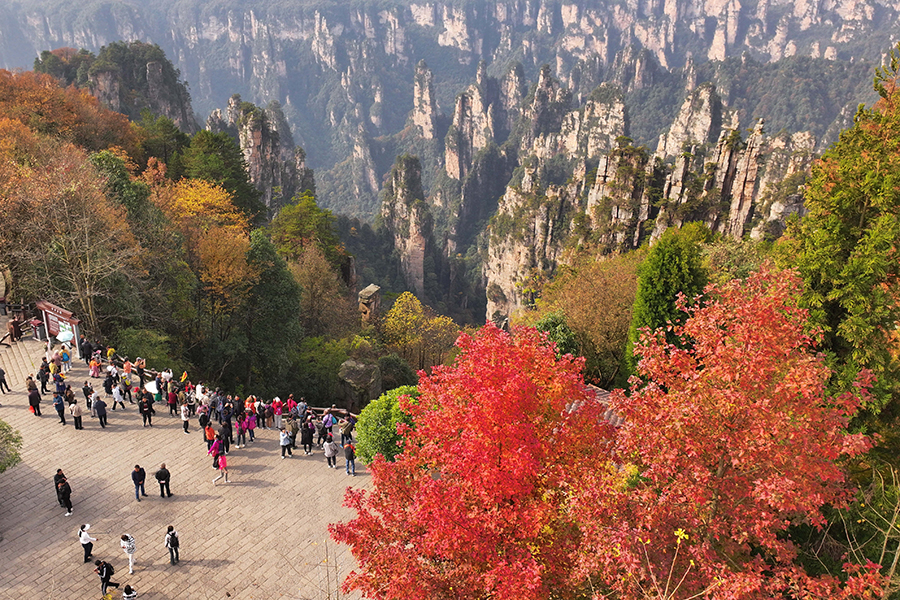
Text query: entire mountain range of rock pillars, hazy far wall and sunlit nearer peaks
0 0 900 316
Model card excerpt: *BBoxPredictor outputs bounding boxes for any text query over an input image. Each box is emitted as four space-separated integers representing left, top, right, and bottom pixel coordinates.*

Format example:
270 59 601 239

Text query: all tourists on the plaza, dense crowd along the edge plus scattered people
26 339 356 598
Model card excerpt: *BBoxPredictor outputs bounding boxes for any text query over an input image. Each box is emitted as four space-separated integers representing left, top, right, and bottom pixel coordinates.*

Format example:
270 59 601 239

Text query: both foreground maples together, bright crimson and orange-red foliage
330 267 882 600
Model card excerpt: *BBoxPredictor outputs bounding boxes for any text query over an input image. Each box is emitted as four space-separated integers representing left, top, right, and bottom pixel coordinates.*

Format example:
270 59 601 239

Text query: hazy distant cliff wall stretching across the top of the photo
0 0 900 216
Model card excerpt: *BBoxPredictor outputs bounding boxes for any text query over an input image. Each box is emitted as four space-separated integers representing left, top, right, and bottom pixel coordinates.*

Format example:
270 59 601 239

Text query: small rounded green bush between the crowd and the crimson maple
356 385 419 464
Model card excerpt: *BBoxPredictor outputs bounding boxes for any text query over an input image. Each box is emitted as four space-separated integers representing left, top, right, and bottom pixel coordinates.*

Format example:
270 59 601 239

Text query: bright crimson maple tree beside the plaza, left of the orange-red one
329 325 604 600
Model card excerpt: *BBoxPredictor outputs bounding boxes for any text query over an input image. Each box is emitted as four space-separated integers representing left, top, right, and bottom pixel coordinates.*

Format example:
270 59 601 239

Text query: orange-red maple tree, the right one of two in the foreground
572 268 878 600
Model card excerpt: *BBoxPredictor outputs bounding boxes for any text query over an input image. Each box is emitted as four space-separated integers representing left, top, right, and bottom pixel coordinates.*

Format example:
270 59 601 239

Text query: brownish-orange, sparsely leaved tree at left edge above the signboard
0 125 143 334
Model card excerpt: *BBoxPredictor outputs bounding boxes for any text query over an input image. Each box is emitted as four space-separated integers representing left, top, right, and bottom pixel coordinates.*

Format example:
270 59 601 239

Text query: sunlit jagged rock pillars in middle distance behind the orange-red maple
482 84 816 318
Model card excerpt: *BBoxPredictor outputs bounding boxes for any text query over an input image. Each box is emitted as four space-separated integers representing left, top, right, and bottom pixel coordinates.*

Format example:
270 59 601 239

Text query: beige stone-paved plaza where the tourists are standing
0 330 369 600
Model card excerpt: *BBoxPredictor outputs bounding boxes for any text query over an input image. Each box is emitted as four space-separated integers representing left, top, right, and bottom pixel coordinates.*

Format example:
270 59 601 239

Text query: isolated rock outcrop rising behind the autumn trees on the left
206 94 315 214
